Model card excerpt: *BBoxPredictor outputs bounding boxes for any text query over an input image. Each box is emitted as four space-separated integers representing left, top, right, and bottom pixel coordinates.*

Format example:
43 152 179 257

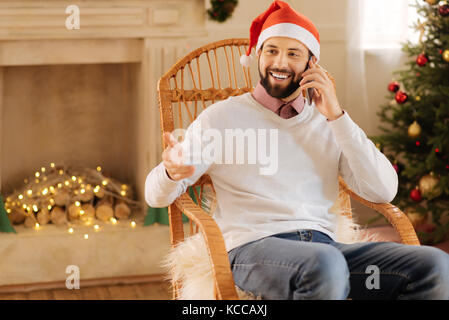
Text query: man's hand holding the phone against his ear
299 61 343 121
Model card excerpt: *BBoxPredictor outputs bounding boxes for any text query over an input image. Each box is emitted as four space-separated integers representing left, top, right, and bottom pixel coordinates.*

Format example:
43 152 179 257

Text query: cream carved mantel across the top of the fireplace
0 0 205 40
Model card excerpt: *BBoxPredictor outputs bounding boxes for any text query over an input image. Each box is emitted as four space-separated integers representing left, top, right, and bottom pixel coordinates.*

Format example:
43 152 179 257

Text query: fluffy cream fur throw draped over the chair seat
162 190 377 300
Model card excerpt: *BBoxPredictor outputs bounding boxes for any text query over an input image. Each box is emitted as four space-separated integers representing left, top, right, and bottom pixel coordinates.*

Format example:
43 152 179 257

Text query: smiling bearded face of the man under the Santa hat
257 37 309 99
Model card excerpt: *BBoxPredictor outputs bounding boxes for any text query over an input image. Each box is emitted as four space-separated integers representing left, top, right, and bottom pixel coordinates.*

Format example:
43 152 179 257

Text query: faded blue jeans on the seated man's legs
229 230 449 300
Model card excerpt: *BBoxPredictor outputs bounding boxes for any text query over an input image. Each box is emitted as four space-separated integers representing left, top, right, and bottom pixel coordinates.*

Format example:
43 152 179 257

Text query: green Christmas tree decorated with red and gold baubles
370 0 449 244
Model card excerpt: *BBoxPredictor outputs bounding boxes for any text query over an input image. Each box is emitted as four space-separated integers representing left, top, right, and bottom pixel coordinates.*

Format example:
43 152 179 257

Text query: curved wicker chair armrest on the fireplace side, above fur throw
174 193 238 300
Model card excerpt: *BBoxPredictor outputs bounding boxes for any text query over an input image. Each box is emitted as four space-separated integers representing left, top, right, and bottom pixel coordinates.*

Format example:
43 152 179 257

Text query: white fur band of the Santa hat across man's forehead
256 23 320 62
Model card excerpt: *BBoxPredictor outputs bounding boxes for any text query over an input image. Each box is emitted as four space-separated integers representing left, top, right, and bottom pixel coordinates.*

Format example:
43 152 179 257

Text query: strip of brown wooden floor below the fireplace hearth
0 282 172 300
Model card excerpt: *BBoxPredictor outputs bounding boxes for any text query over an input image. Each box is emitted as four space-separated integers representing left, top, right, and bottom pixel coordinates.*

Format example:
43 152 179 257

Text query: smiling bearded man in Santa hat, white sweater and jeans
145 1 449 299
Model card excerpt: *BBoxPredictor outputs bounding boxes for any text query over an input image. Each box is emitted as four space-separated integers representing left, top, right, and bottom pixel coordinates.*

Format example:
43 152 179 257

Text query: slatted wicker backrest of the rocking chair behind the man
158 39 351 229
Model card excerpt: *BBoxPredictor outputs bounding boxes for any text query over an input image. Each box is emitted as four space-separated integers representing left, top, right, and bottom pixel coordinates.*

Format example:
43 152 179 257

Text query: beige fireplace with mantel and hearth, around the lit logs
0 0 206 286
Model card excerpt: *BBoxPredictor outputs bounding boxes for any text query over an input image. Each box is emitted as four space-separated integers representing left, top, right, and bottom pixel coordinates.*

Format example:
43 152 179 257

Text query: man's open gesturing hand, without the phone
162 132 195 181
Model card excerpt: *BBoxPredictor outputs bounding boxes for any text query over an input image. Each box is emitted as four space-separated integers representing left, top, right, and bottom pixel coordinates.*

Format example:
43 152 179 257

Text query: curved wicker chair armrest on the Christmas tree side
340 181 420 246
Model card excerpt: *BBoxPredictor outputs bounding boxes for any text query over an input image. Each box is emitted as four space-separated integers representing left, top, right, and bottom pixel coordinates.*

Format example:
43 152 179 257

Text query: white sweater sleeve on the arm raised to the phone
329 111 398 203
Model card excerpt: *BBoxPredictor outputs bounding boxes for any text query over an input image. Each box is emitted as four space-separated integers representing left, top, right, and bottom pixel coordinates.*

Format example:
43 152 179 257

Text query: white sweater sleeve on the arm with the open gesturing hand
145 112 211 208
